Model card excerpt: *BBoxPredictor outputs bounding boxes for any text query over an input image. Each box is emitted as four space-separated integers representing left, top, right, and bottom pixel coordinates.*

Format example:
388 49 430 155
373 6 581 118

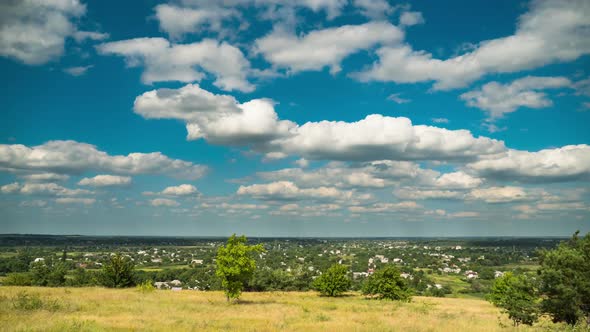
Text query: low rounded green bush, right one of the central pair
362 265 412 302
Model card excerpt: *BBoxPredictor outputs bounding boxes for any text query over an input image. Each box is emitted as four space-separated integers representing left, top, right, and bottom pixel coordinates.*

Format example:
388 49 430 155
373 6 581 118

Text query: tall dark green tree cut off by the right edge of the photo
538 231 590 325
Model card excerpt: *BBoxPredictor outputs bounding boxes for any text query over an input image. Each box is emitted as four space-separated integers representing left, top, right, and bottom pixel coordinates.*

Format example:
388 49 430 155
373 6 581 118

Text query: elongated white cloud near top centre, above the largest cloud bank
255 22 403 73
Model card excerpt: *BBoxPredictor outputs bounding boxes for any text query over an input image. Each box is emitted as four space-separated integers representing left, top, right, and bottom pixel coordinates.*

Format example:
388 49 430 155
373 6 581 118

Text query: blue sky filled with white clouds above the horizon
0 0 590 236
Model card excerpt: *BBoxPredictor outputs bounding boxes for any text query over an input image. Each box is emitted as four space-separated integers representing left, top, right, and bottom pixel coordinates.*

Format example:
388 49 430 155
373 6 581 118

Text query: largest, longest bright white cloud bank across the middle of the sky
134 84 505 161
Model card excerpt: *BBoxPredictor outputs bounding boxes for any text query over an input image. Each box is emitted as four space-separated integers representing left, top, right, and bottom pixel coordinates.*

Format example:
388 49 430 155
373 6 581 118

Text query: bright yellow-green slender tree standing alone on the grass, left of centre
215 234 264 302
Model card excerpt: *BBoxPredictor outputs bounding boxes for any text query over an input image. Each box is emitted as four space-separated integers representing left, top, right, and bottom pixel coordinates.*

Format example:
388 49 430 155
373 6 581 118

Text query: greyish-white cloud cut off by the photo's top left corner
0 0 86 65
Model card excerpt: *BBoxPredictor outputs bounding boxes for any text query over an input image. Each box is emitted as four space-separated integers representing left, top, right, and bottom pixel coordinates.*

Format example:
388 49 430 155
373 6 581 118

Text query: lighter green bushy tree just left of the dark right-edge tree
488 272 540 326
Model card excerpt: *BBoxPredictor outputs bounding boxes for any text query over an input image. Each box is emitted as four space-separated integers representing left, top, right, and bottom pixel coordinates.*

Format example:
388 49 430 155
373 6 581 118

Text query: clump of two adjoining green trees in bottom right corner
489 232 590 328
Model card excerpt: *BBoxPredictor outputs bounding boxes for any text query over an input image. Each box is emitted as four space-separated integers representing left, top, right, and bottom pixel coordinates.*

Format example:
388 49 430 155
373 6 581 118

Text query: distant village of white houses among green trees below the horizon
0 238 551 297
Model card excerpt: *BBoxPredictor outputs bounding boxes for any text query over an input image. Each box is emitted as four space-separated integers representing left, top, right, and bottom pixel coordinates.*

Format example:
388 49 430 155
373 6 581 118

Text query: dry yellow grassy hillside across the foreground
0 287 572 332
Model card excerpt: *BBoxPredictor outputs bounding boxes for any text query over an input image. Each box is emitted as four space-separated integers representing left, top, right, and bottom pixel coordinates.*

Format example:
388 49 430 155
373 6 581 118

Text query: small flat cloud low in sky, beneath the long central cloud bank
237 181 354 200
